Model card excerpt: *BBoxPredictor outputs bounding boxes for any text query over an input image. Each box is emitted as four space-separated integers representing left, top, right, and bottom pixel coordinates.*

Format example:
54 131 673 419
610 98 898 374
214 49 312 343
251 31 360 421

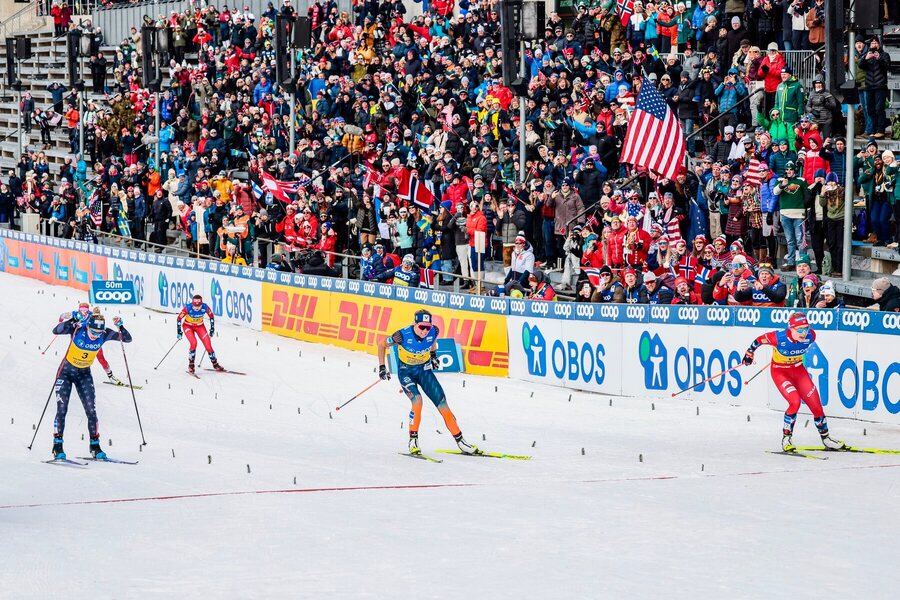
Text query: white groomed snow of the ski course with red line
0 275 900 600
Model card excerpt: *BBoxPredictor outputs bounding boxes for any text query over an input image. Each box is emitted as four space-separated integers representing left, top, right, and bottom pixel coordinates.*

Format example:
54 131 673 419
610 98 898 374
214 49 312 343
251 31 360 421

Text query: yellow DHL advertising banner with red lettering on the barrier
262 283 509 377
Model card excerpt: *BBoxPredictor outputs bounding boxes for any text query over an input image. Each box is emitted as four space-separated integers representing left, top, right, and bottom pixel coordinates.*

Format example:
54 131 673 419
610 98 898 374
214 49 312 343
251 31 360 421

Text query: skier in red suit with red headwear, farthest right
744 312 846 452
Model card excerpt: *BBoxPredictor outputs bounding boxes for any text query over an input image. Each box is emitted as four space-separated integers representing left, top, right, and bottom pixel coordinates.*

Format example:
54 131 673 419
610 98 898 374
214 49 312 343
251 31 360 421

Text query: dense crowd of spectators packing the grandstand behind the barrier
0 0 900 307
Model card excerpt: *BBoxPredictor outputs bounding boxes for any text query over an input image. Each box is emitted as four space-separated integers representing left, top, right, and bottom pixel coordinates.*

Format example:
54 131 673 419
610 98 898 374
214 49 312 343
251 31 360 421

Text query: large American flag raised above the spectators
622 78 686 179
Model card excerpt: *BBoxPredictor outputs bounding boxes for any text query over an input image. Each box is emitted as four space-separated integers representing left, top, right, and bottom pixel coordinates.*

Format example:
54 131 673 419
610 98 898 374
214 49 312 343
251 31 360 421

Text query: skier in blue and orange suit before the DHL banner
378 309 481 454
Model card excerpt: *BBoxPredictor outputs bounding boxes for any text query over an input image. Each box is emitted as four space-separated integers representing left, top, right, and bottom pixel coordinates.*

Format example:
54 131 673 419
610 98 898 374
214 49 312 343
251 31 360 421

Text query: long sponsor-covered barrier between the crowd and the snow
0 229 900 423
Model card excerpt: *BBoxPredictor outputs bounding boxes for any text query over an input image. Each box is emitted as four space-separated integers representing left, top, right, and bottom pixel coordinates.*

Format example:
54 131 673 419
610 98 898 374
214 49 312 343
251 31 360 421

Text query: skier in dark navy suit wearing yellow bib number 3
53 307 131 460
